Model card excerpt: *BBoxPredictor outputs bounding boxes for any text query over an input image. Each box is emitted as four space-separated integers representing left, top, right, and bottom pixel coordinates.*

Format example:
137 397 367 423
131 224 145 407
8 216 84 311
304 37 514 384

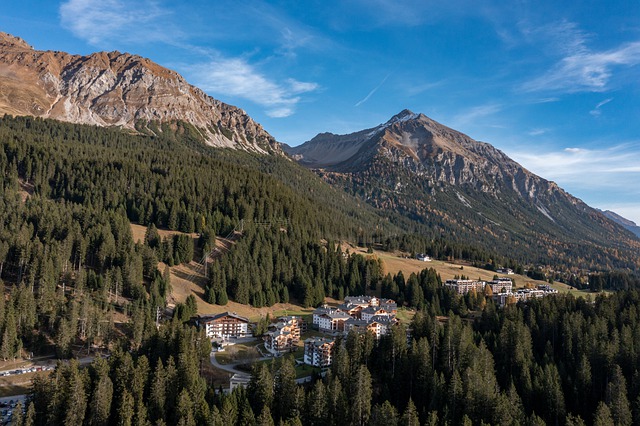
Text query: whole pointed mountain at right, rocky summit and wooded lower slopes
285 110 640 268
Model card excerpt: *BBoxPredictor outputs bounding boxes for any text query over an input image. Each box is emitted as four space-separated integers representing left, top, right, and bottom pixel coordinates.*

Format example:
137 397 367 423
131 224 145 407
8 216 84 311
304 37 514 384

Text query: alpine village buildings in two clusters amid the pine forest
196 272 558 391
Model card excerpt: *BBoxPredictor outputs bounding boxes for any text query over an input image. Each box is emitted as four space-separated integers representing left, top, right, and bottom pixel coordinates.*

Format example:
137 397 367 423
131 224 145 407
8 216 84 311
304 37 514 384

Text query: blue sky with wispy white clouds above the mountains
0 0 640 224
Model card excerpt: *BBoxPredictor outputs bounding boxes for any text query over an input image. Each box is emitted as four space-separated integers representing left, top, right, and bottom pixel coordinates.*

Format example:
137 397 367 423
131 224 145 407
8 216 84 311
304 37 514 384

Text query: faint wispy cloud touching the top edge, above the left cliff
60 0 174 46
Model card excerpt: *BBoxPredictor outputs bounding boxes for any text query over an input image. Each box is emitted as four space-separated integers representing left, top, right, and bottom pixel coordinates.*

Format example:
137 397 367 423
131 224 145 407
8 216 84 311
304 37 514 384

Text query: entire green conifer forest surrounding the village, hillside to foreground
0 116 640 425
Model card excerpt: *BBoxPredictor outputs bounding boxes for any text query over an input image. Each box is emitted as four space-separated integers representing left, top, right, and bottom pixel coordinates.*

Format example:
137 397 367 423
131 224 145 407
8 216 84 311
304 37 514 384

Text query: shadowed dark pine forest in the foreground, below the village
26 290 640 426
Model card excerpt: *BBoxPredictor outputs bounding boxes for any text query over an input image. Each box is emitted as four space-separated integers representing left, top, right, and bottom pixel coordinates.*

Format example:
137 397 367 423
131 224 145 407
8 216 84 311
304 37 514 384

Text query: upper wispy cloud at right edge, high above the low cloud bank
522 21 640 93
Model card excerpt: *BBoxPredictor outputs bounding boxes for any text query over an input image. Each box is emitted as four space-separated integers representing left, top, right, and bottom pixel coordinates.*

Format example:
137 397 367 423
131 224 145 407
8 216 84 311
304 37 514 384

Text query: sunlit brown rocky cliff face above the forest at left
0 33 280 153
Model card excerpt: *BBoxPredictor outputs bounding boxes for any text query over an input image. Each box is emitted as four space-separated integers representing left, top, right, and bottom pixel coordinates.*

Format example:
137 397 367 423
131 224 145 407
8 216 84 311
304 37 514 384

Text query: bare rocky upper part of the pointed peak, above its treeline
287 109 558 200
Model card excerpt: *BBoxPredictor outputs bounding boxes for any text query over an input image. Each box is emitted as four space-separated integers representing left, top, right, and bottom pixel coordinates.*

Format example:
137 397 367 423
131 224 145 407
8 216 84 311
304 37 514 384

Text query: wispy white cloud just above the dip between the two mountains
191 58 319 118
